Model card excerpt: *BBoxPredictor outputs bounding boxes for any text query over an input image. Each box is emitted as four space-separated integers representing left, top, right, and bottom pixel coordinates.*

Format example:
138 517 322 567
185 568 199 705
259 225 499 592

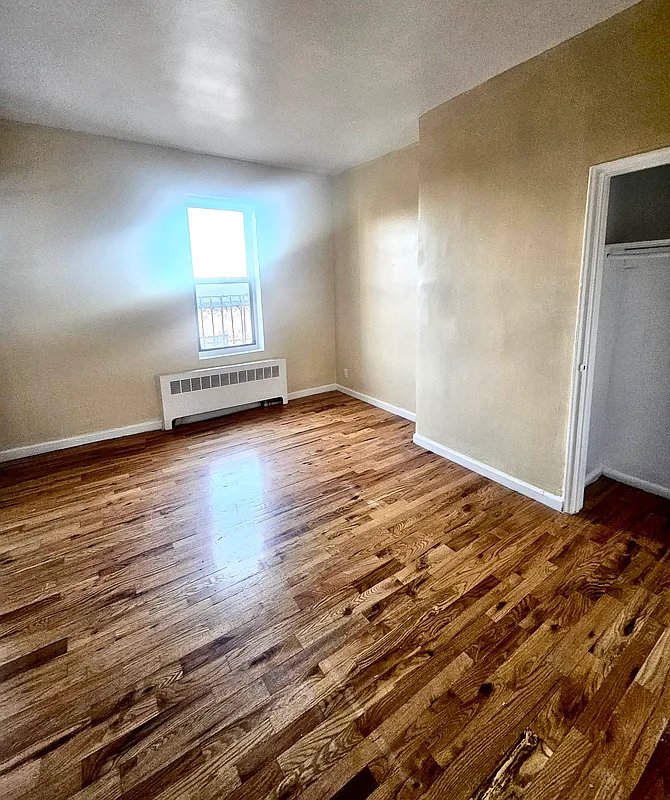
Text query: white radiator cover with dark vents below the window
160 358 288 430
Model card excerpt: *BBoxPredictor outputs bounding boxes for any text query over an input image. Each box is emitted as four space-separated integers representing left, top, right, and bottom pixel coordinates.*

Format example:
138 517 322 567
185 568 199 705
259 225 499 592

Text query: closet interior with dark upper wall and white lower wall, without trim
587 164 670 497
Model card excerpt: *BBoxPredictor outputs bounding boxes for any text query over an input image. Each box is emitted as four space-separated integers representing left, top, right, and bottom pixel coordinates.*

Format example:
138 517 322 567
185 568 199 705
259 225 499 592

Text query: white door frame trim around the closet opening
563 147 670 514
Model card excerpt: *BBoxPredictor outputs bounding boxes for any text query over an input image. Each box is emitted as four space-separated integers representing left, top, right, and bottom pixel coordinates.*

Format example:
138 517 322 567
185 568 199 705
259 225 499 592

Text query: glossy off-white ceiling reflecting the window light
0 0 633 173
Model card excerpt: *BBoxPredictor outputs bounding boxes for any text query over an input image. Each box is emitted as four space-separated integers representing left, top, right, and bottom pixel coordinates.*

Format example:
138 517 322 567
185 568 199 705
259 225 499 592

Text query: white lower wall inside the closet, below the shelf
587 248 670 492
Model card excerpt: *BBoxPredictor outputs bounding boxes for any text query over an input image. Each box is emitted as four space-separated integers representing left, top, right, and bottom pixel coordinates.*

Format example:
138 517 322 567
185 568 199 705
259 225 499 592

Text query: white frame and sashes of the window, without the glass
185 196 265 359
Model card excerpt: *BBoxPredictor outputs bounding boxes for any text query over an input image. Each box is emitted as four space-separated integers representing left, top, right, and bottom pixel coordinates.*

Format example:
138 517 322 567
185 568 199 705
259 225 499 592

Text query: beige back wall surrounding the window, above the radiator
0 122 335 450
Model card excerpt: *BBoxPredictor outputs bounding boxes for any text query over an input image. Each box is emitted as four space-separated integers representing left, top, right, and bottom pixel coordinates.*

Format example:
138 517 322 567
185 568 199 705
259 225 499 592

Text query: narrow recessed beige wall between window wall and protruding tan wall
333 145 418 411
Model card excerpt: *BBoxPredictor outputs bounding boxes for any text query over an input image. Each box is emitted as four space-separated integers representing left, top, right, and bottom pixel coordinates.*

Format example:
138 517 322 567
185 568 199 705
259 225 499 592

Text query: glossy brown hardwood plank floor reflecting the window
0 393 670 800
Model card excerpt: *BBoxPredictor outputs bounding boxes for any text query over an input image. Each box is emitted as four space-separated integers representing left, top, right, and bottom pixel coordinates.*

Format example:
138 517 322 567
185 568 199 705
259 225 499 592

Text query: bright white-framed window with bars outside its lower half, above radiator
187 202 263 358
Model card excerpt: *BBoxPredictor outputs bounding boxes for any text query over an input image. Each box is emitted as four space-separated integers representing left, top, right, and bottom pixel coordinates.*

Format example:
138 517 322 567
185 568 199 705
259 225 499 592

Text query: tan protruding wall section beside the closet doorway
417 0 670 493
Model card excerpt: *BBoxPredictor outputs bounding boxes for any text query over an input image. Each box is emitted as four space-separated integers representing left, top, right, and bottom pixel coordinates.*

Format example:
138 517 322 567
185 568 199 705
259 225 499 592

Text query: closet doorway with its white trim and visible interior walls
564 148 670 513
